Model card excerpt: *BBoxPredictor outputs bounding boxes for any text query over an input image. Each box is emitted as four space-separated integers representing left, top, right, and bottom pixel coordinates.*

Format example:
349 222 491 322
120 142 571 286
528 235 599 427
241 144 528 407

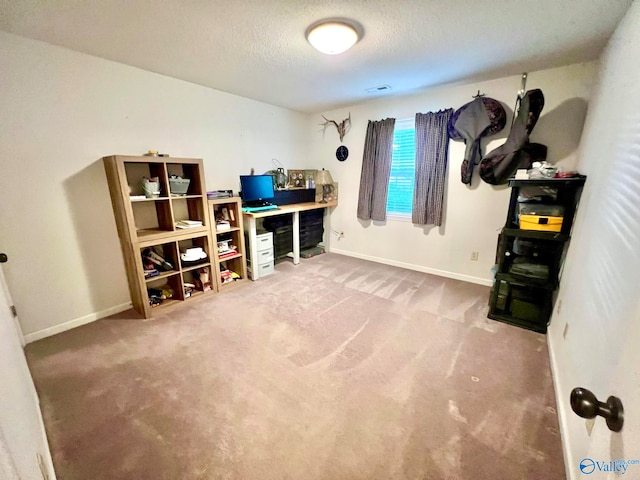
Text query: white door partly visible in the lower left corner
0 260 55 480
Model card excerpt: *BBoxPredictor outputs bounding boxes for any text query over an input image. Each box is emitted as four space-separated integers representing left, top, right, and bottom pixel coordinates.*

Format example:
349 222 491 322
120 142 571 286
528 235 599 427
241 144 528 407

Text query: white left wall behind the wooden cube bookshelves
0 32 308 340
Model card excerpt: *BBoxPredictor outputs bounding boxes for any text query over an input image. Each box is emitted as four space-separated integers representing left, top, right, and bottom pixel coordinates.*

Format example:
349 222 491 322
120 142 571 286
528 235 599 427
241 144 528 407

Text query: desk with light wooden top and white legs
242 200 338 280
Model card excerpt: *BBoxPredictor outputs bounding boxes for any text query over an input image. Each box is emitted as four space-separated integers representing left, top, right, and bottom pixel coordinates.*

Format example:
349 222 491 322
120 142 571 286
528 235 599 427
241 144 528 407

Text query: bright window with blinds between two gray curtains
387 118 416 218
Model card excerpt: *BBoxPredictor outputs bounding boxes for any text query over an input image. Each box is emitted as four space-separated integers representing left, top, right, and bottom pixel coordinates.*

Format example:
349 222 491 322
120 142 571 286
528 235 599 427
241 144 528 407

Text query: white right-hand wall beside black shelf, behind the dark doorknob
548 1 640 479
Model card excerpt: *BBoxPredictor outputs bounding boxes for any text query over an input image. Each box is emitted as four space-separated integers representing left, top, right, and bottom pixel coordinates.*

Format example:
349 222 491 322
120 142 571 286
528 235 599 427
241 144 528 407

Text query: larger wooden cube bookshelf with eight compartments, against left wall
103 155 218 318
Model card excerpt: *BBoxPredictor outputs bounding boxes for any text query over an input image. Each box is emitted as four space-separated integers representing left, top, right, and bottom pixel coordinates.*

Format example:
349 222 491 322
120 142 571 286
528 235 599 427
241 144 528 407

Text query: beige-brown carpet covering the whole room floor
27 254 564 480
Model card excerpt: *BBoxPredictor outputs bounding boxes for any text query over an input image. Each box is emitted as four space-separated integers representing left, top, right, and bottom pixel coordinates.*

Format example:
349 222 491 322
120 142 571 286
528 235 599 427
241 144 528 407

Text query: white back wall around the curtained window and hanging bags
310 63 597 284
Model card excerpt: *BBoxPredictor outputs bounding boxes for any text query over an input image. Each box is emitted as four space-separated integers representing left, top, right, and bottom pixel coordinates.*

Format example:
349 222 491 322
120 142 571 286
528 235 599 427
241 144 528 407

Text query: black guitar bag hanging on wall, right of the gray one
480 89 547 185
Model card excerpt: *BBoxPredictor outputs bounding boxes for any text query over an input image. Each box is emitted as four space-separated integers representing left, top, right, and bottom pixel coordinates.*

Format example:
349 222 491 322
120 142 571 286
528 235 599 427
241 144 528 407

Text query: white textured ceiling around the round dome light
0 0 632 112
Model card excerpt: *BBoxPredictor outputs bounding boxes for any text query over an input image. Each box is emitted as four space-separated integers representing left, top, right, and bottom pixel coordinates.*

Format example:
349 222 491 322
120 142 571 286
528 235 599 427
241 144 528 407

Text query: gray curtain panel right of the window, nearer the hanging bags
411 108 453 226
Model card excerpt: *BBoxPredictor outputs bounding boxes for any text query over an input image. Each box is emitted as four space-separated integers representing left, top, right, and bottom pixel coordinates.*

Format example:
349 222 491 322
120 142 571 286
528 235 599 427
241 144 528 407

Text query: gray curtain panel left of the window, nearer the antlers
358 118 396 221
